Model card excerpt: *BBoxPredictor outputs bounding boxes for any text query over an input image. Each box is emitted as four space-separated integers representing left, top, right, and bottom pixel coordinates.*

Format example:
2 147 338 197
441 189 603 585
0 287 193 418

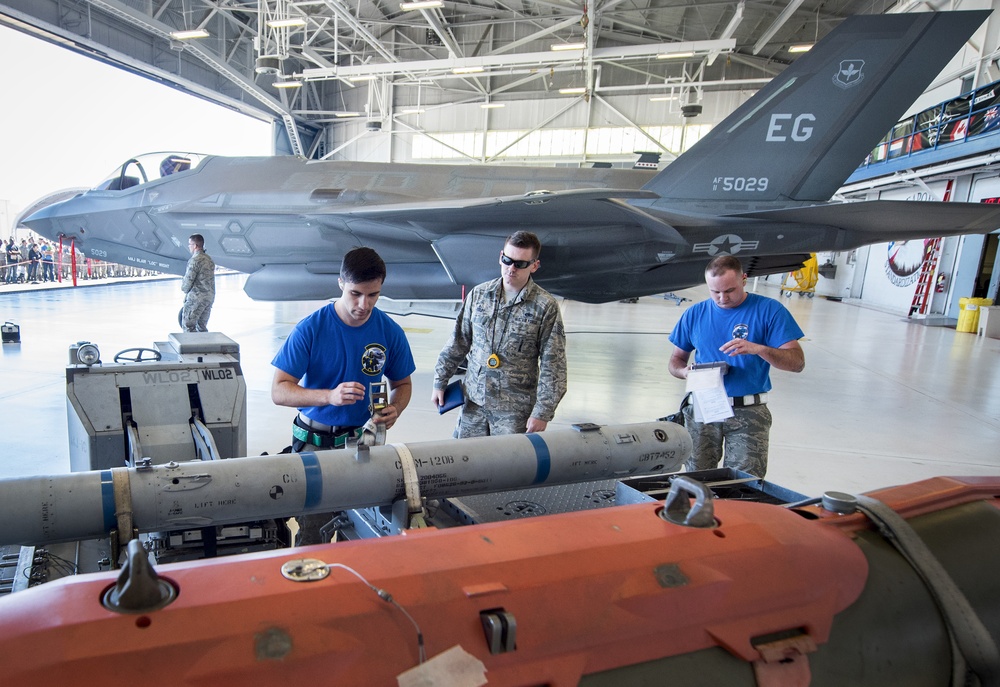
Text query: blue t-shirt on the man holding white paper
670 293 803 396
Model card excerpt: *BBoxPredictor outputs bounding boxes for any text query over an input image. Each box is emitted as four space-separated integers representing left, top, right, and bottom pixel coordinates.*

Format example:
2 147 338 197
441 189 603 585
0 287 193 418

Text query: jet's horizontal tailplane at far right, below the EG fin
727 200 1000 243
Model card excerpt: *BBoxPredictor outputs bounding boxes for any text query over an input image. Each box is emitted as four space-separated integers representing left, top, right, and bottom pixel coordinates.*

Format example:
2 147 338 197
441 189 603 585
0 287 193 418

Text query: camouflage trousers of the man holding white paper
684 403 771 478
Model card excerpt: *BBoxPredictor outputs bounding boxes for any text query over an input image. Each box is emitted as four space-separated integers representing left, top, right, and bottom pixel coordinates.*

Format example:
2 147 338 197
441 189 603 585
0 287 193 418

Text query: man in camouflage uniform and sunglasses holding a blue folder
431 231 566 439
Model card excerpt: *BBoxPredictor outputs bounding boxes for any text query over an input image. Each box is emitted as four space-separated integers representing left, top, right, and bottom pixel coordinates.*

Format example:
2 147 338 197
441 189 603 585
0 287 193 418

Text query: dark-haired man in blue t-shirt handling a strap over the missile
271 248 416 546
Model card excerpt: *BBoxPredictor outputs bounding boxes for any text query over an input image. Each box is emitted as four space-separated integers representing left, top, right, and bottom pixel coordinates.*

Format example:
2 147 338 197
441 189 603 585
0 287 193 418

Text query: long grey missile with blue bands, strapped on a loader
0 422 691 545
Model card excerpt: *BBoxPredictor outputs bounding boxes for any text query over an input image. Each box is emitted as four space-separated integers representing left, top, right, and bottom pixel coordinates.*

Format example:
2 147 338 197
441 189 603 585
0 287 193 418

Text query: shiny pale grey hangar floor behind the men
0 275 1000 495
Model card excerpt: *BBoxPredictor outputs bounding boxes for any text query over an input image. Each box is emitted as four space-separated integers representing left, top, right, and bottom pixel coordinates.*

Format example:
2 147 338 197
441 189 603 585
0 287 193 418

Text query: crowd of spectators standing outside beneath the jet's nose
0 236 154 284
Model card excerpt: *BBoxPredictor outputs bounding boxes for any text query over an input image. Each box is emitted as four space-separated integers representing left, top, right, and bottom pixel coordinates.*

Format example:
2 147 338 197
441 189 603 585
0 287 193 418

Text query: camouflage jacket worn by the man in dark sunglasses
434 279 566 422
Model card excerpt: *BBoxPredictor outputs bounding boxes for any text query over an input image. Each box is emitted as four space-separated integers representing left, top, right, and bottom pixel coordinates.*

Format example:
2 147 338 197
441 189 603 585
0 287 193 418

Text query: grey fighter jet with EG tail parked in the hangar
23 11 1000 303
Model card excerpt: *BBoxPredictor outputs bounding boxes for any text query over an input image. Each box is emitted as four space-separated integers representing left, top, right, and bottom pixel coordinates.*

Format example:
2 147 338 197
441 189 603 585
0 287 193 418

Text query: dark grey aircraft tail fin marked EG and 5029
644 10 989 207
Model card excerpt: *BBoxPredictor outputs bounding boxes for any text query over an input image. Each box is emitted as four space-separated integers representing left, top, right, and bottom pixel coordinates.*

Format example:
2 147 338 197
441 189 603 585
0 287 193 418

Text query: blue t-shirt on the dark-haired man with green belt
271 303 416 427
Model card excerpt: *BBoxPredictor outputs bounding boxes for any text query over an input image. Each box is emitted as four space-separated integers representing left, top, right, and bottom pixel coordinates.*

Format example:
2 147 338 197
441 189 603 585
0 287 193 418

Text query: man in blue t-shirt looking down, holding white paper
669 255 806 477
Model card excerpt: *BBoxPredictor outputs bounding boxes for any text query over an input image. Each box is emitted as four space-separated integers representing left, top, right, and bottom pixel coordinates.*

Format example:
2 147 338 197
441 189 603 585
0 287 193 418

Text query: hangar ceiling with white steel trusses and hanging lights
0 0 988 159
